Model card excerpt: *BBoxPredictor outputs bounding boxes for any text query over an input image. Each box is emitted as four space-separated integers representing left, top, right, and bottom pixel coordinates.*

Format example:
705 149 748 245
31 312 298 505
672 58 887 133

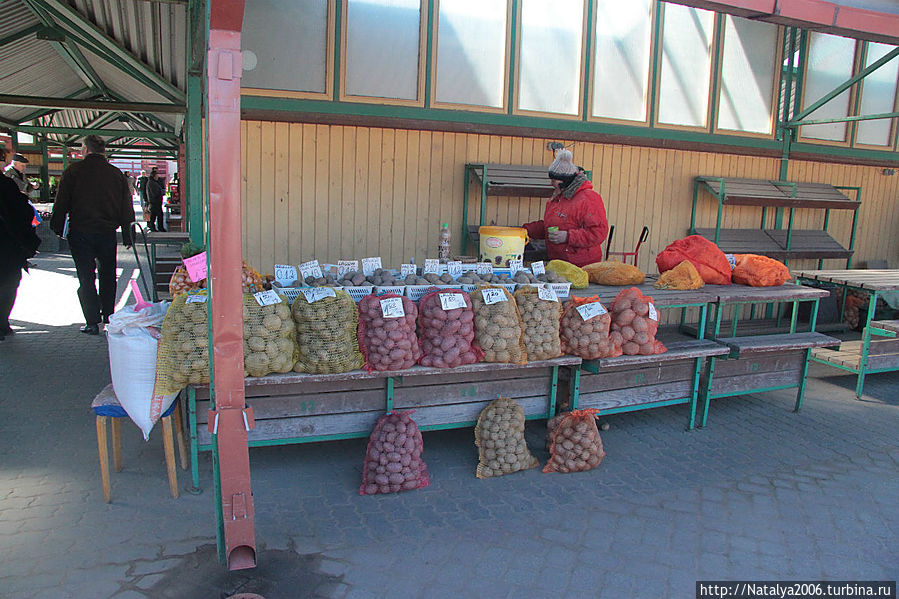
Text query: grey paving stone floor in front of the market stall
0 250 899 599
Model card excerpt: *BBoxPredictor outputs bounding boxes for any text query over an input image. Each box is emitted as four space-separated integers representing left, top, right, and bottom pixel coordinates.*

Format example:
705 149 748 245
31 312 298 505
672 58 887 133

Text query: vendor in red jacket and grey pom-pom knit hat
524 149 609 266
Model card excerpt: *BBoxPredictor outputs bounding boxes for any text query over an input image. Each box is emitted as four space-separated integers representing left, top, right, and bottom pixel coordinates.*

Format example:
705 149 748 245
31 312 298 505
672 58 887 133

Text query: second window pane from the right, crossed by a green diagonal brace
801 32 855 141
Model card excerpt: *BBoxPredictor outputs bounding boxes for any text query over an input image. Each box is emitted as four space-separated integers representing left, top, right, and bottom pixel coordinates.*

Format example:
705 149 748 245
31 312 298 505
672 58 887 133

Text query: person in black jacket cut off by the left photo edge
0 148 41 340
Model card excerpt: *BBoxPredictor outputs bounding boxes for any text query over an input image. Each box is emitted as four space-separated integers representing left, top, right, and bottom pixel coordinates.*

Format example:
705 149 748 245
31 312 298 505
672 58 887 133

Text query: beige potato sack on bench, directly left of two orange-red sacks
515 287 562 360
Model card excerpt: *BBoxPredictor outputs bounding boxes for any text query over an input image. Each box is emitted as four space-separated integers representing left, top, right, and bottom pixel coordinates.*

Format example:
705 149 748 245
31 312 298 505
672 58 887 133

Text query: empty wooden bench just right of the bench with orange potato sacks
700 332 840 426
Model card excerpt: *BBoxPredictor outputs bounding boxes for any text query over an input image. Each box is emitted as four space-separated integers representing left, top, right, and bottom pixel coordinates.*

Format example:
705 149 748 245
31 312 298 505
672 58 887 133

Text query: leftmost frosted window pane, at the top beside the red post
240 0 328 93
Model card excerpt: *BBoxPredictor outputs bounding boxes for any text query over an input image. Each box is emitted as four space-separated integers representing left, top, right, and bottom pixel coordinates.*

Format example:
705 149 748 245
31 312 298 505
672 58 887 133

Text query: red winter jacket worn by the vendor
524 181 609 266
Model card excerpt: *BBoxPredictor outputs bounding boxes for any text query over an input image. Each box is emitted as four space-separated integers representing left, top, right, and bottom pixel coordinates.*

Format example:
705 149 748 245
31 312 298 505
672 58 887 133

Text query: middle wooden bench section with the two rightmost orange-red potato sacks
570 339 730 430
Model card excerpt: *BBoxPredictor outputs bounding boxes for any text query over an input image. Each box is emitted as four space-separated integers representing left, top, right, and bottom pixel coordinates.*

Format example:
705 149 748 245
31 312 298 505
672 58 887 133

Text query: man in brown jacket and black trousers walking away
50 135 134 335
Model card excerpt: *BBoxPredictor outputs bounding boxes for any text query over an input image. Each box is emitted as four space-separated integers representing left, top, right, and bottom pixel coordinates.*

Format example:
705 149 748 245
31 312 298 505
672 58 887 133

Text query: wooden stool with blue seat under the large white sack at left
91 384 187 503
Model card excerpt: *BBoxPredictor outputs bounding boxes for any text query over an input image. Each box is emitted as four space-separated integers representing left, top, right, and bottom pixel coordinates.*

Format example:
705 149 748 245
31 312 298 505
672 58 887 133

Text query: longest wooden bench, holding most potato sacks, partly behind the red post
187 356 581 487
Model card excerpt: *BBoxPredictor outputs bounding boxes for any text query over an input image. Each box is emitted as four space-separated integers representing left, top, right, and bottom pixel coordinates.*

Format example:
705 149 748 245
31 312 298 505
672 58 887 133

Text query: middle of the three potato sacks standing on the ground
474 397 540 478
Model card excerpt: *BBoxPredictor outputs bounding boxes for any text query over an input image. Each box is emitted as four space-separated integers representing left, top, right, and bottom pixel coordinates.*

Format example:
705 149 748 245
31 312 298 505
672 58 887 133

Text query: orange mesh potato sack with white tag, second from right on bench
559 295 621 360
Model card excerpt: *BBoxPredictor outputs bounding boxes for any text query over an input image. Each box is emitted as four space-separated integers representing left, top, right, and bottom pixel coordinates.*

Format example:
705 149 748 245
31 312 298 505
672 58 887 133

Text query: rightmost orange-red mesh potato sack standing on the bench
609 287 668 356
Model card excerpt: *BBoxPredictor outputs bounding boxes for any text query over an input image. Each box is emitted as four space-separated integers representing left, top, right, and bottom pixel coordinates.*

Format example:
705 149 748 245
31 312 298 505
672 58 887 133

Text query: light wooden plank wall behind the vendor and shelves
241 121 899 272
